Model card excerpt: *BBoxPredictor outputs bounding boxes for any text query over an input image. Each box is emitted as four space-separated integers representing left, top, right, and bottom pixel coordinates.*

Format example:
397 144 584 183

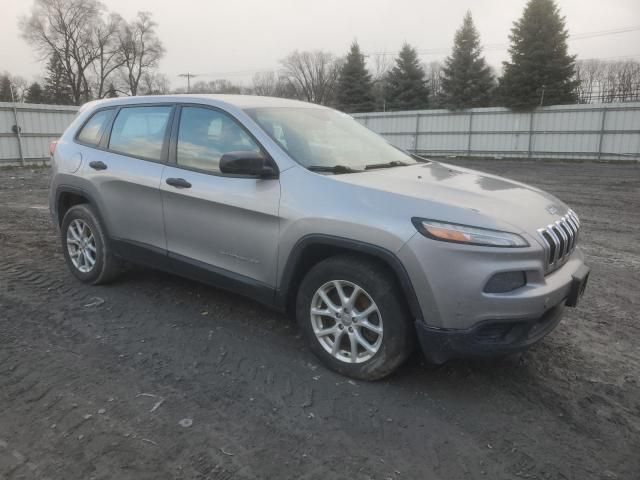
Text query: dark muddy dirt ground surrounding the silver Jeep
0 160 640 480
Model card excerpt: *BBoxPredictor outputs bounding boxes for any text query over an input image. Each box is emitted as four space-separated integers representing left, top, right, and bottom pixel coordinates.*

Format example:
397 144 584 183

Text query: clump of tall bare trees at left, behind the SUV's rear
0 0 164 105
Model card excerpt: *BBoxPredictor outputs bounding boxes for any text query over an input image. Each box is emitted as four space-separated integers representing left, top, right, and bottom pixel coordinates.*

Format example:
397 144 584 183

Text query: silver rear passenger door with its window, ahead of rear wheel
84 104 174 252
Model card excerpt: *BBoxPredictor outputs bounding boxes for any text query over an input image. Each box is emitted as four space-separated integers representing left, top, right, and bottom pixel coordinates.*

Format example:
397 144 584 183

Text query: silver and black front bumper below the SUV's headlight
399 234 584 330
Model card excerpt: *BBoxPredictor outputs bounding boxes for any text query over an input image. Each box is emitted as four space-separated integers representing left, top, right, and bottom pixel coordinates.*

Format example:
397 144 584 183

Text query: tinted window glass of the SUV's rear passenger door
109 106 171 160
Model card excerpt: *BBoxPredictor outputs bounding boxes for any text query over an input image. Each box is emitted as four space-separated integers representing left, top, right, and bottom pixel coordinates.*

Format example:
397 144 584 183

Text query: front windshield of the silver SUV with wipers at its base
247 108 418 173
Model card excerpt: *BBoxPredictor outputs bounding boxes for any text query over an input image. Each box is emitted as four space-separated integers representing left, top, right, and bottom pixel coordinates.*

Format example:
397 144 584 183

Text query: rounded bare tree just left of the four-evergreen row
281 50 341 105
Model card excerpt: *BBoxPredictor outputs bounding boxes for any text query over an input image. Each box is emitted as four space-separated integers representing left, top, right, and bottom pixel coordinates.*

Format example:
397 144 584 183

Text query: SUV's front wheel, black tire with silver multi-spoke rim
296 255 415 380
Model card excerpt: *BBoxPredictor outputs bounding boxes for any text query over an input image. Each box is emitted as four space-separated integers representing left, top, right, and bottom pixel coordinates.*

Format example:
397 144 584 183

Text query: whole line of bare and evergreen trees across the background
5 0 640 112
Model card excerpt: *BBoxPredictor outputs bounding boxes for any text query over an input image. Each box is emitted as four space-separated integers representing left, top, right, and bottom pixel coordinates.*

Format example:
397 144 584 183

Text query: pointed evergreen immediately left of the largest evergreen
441 12 494 110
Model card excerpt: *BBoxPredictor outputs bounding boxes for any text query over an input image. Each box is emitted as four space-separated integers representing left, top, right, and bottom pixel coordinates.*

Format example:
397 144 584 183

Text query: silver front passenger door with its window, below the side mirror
160 105 280 294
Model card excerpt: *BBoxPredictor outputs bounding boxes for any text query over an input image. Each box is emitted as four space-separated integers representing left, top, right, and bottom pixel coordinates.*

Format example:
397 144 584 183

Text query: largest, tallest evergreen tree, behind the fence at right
499 0 578 108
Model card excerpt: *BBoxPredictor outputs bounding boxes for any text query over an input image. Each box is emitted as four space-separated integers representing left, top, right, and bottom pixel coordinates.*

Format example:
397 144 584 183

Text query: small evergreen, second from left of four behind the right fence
384 43 429 110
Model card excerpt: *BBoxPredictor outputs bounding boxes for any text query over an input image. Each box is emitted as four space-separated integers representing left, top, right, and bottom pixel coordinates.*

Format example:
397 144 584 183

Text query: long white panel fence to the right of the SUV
354 102 640 161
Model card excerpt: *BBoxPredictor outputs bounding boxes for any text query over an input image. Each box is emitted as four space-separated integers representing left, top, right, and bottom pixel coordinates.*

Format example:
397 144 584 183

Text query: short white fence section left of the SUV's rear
0 102 78 165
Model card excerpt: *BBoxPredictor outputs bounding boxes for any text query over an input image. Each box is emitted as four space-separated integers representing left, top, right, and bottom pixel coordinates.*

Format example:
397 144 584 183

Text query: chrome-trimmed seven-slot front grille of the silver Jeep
538 210 580 273
